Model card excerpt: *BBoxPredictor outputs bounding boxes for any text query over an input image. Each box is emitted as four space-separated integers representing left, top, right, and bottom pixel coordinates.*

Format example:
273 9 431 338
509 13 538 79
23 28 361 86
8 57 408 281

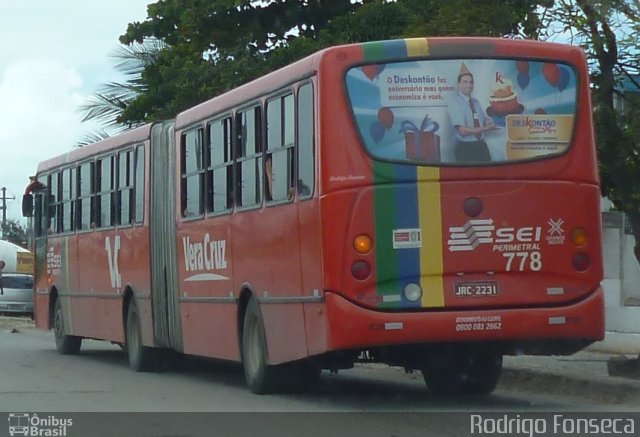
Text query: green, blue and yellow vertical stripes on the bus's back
362 38 444 309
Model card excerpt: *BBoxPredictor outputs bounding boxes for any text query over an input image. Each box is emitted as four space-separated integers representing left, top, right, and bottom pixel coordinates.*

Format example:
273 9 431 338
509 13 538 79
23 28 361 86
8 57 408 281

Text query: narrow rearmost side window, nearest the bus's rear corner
297 83 315 199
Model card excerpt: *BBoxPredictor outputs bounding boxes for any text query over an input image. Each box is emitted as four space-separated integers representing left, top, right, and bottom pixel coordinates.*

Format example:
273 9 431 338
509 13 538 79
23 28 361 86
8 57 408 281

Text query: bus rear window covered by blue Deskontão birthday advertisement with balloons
346 59 577 165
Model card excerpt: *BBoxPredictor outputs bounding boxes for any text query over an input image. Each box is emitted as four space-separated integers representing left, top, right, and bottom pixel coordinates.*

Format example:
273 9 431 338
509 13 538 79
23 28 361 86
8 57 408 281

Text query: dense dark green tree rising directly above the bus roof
118 0 549 124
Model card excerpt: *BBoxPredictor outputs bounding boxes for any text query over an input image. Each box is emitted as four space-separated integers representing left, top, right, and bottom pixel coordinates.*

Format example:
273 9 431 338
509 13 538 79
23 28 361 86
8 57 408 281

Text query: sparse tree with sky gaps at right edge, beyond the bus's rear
544 0 640 259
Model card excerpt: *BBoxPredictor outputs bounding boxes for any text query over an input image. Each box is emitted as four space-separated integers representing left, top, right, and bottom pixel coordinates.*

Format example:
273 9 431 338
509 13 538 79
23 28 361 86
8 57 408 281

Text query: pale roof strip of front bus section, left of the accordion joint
38 123 153 173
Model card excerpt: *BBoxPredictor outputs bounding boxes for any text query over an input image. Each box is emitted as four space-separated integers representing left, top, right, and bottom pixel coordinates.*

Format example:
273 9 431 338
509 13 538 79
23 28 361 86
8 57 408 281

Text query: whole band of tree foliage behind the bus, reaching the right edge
79 0 640 262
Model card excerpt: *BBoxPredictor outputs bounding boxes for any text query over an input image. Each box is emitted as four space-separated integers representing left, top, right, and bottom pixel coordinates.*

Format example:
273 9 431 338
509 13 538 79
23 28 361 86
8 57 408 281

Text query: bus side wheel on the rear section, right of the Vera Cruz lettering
242 299 279 394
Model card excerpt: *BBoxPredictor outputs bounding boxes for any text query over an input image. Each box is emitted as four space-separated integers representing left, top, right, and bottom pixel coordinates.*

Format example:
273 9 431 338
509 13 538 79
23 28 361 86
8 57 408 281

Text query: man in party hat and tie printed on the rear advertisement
447 62 496 162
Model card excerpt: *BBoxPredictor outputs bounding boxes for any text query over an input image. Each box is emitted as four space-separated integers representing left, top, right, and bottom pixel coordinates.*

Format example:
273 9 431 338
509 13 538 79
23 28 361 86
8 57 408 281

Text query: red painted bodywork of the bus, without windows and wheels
28 38 604 370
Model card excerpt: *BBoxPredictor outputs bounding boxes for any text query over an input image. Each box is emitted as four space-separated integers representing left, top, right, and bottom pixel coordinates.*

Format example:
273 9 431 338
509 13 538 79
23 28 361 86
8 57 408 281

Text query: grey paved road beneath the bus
0 318 640 437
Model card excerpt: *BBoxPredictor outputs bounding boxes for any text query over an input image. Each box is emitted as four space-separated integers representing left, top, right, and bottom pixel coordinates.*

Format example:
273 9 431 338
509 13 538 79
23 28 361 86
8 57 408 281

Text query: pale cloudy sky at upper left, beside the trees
0 0 154 223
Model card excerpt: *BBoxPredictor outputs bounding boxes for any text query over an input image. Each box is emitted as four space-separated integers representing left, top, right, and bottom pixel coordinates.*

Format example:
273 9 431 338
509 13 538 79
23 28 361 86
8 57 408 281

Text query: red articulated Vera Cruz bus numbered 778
24 38 604 393
